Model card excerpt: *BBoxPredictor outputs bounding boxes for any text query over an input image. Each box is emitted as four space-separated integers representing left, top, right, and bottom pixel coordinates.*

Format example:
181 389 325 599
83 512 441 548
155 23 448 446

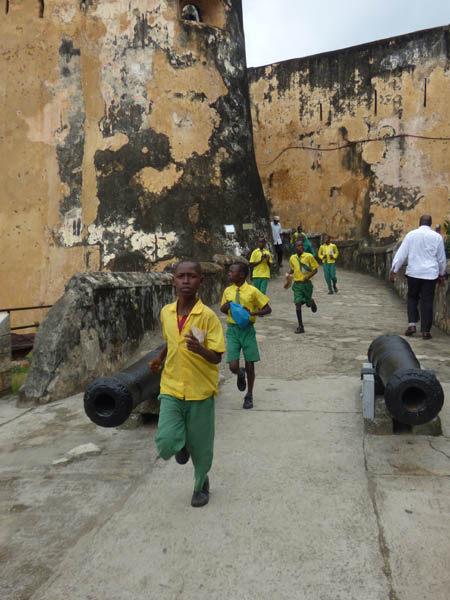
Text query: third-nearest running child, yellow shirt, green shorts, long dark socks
285 239 319 333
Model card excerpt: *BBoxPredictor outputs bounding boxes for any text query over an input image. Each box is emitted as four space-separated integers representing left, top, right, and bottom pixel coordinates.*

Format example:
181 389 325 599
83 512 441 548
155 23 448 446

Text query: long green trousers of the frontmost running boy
156 394 214 492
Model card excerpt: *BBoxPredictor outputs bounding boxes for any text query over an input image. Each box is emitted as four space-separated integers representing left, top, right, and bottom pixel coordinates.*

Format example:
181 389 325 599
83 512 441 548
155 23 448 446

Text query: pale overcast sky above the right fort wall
242 0 450 67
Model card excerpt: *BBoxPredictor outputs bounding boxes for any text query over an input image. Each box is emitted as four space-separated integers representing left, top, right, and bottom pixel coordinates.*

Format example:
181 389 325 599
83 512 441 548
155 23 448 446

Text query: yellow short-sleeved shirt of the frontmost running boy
160 299 225 400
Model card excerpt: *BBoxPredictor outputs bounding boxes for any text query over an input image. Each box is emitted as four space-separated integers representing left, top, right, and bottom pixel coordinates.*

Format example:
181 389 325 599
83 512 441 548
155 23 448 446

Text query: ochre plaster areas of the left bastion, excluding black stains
0 0 237 325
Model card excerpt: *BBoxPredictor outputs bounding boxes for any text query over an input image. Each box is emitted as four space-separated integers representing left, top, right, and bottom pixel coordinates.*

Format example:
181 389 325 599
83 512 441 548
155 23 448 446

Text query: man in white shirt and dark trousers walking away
390 215 447 340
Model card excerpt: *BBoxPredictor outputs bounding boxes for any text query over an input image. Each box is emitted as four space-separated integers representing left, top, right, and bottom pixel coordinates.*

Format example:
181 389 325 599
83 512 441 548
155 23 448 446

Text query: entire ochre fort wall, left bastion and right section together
0 0 450 325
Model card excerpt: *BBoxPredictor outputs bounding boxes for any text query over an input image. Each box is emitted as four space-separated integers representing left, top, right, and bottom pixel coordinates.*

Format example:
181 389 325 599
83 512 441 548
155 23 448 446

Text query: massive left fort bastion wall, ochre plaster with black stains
0 0 267 324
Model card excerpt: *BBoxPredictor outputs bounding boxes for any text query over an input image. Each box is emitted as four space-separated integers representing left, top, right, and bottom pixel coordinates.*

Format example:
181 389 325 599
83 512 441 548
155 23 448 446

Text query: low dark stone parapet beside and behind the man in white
336 240 450 334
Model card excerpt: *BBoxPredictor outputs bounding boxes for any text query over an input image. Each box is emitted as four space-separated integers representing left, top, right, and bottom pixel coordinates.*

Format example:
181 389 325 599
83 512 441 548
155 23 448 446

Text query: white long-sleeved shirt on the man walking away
391 225 447 279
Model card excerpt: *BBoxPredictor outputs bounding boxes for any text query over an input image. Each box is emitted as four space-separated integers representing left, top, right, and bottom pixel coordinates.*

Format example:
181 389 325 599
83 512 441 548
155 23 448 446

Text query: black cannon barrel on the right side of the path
368 335 444 425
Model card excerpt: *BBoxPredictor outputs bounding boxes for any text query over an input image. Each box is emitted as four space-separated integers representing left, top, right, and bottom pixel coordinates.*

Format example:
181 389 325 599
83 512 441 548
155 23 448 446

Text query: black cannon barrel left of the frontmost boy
84 346 163 427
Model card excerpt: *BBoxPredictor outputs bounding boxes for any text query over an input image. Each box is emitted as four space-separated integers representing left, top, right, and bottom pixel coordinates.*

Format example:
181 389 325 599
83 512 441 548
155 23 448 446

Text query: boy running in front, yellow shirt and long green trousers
149 261 225 507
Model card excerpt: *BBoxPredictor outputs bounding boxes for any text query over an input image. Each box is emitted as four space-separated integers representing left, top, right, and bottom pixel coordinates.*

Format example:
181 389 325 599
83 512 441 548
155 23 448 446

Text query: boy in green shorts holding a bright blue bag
220 262 272 408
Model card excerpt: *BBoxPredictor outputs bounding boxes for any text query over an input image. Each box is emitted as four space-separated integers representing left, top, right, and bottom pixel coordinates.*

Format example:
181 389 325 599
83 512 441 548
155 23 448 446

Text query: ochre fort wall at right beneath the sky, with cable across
249 27 450 244
